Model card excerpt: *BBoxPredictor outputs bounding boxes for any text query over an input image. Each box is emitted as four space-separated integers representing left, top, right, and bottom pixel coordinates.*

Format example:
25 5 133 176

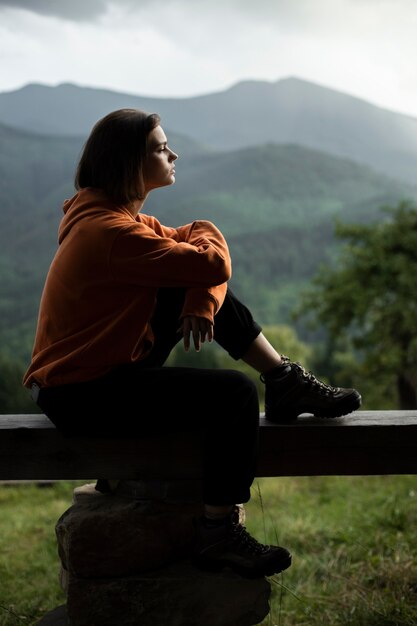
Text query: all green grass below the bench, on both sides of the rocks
0 476 417 626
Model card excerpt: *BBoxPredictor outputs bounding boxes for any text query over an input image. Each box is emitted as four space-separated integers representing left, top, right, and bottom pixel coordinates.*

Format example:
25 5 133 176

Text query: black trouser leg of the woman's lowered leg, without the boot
38 365 259 505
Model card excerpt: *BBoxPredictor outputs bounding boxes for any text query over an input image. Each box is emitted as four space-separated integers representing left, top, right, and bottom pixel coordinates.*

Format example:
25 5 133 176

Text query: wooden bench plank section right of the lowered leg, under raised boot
258 411 417 476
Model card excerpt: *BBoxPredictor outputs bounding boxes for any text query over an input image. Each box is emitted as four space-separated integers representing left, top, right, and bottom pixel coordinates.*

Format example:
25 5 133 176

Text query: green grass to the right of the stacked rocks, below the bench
246 476 417 626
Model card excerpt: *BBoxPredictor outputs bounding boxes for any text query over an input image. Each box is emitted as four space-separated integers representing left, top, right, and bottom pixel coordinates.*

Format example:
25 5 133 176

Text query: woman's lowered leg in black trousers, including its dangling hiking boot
35 291 291 577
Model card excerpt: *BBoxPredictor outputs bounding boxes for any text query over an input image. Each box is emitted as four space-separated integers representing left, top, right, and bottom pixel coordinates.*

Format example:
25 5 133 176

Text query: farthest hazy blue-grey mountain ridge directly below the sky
0 77 417 184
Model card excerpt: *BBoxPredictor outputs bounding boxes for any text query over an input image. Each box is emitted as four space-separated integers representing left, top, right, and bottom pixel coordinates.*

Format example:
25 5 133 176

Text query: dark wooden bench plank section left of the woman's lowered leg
0 416 202 480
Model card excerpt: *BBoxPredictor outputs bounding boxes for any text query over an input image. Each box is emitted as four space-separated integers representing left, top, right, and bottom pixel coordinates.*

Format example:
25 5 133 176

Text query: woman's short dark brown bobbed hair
74 109 160 204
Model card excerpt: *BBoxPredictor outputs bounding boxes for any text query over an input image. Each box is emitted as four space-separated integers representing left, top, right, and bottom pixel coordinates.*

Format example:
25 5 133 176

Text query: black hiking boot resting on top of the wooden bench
260 355 362 424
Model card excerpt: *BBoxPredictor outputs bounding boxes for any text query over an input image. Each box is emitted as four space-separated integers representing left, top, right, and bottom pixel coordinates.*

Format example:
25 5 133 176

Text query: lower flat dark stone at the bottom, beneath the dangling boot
67 561 271 626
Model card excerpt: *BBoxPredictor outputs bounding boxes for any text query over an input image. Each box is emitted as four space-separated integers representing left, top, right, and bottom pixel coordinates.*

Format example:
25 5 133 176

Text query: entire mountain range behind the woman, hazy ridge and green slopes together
0 79 417 360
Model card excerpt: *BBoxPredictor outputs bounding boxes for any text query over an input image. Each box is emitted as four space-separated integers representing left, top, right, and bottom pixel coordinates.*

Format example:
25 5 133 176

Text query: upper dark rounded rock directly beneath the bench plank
55 487 202 578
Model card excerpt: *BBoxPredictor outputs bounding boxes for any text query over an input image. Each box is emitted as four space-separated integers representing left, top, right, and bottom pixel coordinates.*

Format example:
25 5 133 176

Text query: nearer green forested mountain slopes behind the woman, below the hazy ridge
0 117 417 361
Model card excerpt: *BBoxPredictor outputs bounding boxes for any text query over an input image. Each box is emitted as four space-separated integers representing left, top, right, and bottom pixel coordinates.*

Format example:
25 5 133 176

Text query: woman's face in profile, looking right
143 126 178 193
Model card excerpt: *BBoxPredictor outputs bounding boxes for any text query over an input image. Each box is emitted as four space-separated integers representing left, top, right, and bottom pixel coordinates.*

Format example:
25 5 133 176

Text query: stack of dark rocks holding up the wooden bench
56 482 271 626
